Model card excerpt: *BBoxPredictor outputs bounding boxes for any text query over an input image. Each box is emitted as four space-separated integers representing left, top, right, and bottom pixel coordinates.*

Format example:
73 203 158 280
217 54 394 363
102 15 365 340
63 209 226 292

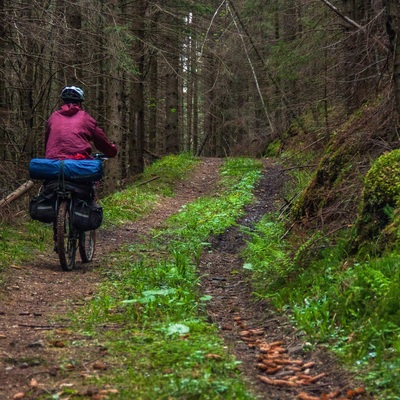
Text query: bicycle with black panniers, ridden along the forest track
30 154 107 271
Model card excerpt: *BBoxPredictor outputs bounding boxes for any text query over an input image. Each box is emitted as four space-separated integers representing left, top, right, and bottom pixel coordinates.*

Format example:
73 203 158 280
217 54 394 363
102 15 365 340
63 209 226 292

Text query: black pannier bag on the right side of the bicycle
72 199 103 232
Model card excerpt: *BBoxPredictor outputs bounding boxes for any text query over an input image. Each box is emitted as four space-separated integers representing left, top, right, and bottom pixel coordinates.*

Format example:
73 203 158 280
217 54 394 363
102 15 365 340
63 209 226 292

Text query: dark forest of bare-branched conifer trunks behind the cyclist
0 0 400 197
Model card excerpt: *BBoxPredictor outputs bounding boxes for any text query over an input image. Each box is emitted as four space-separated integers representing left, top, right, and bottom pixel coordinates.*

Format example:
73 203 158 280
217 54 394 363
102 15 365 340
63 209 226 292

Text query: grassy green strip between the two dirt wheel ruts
65 158 262 400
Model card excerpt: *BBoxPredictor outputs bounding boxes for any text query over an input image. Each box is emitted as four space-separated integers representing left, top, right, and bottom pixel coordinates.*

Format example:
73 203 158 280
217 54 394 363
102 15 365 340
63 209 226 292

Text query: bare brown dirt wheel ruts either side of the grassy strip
0 158 370 400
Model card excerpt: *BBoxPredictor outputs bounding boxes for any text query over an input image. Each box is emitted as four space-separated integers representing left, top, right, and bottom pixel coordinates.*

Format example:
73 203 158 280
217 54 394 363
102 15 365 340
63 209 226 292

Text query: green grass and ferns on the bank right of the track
244 166 400 400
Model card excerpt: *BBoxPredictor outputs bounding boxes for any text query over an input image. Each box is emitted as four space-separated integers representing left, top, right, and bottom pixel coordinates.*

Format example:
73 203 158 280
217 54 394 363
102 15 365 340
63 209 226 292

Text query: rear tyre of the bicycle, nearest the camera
56 200 77 271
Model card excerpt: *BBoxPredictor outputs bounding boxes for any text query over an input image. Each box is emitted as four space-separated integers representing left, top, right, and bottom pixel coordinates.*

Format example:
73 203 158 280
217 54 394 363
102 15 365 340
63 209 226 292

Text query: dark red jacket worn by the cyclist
45 104 118 160
